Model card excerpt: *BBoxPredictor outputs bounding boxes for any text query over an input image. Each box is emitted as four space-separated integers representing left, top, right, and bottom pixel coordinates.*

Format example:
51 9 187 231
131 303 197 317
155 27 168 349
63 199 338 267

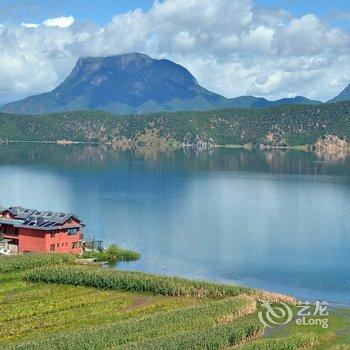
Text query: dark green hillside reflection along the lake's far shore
0 143 350 175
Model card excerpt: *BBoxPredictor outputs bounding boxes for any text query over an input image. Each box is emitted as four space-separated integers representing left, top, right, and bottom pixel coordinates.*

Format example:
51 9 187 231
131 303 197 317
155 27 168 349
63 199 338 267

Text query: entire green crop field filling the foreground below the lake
0 254 350 350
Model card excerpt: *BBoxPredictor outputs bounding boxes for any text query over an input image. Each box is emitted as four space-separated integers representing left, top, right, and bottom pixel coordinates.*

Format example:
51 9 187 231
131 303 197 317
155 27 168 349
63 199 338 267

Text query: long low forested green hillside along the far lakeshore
0 102 350 146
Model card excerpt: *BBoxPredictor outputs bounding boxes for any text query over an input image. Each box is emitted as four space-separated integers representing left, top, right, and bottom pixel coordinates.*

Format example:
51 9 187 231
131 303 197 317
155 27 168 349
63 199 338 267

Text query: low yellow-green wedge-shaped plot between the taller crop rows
0 273 198 344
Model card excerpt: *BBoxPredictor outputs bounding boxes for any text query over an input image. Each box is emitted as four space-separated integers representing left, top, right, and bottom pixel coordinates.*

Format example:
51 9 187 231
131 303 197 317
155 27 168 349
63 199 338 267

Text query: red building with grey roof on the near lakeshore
0 207 84 253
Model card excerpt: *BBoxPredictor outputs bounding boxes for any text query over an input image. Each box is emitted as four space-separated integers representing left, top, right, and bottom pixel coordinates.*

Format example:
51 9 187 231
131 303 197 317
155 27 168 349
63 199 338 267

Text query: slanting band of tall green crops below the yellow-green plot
0 296 262 350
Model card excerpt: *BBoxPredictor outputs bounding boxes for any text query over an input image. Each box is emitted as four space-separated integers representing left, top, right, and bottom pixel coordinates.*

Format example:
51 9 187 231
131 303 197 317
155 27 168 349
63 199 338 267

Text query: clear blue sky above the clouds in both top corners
0 0 350 28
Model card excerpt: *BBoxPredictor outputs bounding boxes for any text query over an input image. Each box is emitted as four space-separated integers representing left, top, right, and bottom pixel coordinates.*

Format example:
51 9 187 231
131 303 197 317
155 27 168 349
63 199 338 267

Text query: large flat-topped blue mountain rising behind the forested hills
0 53 317 114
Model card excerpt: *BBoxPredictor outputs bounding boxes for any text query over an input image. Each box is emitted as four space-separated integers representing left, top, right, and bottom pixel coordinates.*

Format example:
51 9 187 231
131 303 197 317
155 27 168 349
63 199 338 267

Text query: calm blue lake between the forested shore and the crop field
0 144 350 304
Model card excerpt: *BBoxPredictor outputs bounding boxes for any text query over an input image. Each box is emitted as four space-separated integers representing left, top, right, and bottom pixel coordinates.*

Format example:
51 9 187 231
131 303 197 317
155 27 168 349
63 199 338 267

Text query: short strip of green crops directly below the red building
0 253 76 273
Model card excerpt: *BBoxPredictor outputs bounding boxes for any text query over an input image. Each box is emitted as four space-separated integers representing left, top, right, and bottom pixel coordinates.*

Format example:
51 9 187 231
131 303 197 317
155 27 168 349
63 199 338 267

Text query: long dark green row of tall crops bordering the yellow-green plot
26 266 253 298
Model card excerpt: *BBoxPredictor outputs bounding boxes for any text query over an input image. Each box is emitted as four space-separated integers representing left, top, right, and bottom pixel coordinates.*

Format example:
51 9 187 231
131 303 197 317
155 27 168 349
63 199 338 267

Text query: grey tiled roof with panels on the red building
0 207 81 230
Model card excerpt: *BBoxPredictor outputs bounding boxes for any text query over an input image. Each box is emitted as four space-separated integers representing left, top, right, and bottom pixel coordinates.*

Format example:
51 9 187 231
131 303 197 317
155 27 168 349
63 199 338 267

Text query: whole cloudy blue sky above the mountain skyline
0 0 350 104
